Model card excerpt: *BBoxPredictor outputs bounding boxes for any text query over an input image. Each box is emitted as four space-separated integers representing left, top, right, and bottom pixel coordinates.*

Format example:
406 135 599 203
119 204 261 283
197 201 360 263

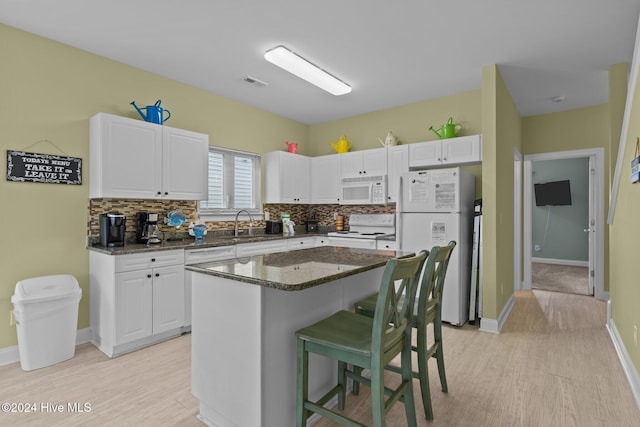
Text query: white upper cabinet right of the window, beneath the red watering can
264 151 311 203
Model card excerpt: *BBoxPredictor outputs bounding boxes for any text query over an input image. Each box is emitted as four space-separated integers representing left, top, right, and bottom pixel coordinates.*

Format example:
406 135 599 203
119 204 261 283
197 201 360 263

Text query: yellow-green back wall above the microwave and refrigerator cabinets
309 90 482 197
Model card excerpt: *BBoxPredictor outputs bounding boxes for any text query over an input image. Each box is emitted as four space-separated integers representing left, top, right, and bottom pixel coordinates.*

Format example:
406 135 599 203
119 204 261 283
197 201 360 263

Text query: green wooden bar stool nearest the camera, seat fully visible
296 251 427 427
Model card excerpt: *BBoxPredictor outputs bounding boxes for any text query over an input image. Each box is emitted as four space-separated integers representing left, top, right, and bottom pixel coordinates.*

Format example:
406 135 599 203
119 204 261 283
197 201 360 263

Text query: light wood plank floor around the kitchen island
0 291 640 427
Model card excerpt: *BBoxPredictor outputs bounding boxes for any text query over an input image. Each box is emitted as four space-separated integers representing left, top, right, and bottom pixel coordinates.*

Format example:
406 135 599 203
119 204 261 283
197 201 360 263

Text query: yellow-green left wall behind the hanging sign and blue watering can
0 25 309 348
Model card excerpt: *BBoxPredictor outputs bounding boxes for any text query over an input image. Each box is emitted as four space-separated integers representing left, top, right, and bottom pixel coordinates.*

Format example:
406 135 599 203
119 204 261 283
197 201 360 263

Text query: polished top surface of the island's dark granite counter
185 246 413 291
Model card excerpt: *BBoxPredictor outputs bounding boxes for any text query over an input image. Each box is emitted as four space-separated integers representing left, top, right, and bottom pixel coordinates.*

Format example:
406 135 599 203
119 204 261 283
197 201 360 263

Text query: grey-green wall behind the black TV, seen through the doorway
531 157 589 260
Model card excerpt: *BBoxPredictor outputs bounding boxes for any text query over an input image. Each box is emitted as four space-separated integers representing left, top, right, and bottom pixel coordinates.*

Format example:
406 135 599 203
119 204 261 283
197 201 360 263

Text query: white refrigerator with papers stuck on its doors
396 168 475 326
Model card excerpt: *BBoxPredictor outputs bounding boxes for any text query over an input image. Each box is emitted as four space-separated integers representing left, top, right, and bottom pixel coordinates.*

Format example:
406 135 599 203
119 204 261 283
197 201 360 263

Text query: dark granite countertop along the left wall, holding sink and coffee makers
87 232 327 255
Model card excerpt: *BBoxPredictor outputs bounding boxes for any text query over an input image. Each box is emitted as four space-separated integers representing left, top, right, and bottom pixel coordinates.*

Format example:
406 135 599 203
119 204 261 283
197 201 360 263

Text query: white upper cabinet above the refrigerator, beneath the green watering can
409 135 482 169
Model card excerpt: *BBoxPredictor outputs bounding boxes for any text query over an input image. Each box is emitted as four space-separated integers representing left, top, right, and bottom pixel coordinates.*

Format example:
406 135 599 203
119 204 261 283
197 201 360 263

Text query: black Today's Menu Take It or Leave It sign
7 150 82 185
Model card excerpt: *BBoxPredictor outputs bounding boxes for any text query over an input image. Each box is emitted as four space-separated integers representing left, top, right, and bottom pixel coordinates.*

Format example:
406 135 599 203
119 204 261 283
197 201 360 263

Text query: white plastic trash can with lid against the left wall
11 274 82 371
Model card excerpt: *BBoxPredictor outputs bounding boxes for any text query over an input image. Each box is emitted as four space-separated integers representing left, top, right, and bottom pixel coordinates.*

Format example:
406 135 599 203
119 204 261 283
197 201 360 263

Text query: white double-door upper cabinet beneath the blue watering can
89 113 209 200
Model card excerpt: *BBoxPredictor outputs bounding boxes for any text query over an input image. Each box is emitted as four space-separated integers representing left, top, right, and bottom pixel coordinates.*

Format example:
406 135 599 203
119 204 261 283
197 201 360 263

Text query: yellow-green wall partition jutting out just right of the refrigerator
482 65 521 319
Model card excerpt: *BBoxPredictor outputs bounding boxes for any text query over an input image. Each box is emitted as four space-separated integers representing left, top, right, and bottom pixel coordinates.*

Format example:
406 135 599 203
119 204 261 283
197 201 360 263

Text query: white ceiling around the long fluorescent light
0 0 640 124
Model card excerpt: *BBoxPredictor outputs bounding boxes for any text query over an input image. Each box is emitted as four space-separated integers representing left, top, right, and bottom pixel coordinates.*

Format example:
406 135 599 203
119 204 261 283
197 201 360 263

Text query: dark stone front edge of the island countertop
184 252 415 291
